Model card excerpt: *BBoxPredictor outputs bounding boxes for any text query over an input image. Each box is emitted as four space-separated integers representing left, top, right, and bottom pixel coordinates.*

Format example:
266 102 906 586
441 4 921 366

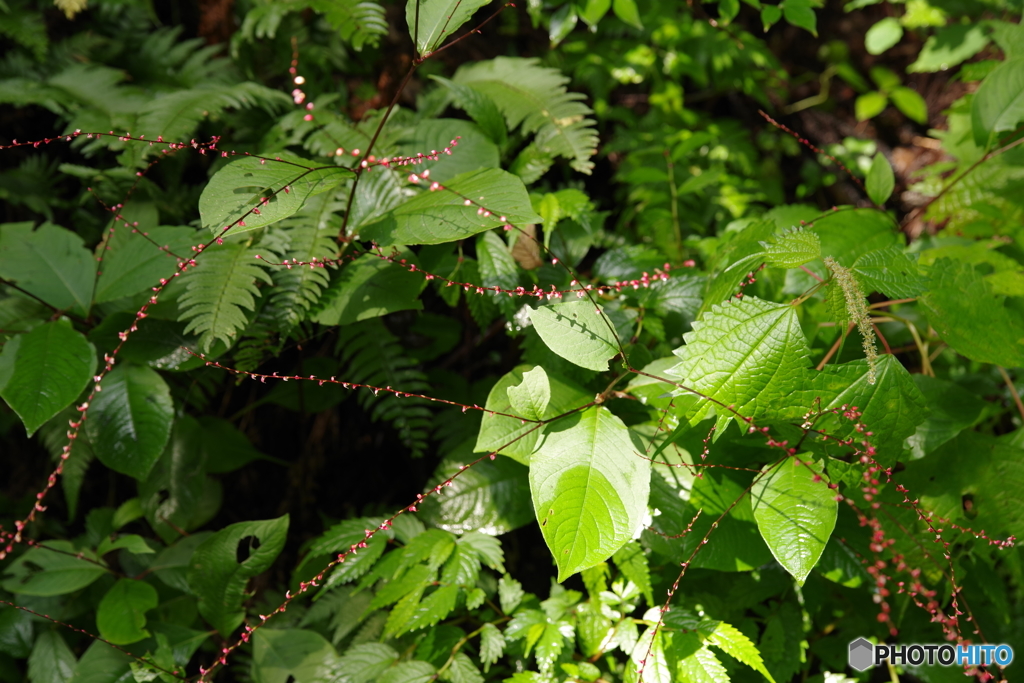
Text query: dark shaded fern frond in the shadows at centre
337 318 431 458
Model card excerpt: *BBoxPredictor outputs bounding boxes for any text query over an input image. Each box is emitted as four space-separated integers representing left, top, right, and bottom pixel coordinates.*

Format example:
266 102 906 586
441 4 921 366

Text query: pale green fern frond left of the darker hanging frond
178 242 272 351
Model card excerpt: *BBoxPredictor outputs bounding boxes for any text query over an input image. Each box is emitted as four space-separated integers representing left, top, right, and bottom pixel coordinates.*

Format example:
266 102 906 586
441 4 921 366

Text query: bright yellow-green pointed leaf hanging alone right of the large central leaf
751 456 839 586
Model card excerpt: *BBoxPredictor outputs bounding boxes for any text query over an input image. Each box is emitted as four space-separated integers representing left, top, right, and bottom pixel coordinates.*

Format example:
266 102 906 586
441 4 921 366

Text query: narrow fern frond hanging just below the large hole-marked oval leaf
266 193 344 334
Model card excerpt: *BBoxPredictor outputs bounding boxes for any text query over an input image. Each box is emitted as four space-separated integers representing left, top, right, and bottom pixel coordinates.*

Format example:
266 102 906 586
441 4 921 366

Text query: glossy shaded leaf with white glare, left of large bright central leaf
421 442 534 536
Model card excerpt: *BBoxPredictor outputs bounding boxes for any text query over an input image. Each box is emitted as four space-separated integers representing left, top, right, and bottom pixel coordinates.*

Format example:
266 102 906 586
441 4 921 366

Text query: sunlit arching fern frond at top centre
453 57 597 174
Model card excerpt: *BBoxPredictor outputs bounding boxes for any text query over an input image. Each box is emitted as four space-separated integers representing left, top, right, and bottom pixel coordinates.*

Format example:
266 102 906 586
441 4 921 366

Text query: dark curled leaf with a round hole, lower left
188 515 288 636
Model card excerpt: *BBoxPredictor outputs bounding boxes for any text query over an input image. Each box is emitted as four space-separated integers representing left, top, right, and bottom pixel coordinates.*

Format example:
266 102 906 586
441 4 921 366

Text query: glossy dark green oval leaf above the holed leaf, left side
85 364 174 479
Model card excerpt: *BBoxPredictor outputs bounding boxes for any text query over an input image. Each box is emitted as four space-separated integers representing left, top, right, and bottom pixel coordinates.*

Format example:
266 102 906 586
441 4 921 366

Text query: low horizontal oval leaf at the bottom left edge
2 541 108 597
